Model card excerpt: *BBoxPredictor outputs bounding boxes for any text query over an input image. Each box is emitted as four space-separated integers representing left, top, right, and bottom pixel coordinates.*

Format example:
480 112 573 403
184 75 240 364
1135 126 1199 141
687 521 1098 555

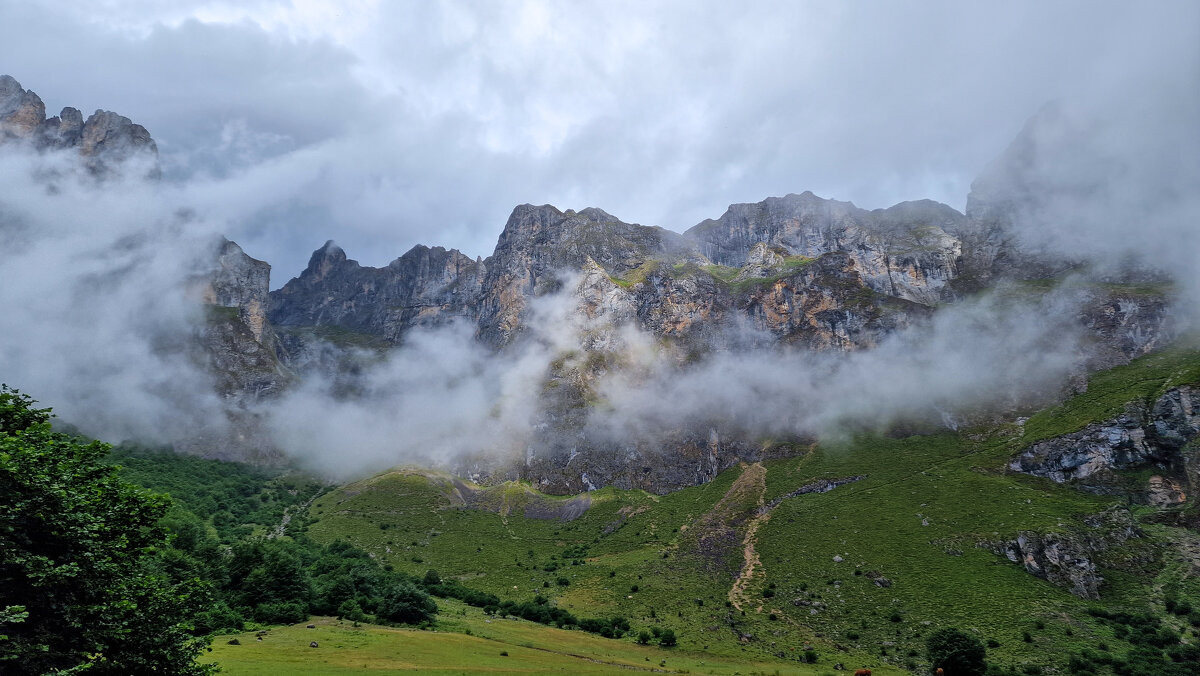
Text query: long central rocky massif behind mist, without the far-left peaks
241 128 1176 493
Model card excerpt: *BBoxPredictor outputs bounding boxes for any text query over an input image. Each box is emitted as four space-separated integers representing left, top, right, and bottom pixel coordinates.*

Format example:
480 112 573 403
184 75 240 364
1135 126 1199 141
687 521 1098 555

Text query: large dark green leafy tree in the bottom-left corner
0 385 214 676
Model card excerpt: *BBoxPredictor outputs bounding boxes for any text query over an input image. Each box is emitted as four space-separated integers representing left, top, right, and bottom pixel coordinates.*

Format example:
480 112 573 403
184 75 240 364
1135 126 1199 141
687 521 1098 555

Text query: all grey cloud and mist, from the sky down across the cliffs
0 2 1200 487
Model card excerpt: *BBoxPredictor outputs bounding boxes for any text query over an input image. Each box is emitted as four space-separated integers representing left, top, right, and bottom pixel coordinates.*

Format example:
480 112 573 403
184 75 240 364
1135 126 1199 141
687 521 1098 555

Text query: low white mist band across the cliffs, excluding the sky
0 83 1200 479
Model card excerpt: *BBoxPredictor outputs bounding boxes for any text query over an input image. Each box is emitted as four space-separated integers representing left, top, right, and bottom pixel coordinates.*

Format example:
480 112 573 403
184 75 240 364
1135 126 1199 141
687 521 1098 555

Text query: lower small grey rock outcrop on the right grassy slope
979 508 1150 600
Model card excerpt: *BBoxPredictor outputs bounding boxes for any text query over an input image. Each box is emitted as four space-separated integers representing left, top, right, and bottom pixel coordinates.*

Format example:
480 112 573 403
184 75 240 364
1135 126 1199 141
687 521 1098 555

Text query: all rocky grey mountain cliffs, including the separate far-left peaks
0 76 1178 493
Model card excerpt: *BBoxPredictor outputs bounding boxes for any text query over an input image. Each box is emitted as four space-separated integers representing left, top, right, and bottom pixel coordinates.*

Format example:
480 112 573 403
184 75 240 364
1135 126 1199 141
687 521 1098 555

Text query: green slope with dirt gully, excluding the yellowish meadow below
226 351 1200 674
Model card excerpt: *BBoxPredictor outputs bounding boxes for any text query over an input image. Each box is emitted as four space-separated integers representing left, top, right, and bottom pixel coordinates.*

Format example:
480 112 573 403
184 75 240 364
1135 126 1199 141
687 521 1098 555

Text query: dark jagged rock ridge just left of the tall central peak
270 241 485 345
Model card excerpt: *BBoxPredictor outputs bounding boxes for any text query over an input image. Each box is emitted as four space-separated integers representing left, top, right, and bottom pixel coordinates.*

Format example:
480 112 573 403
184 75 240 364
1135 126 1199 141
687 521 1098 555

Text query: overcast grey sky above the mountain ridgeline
0 0 1200 280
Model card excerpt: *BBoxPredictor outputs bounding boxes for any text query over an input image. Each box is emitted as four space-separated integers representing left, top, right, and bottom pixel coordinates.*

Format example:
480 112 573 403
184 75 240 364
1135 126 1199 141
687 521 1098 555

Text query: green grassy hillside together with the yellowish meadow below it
196 349 1200 675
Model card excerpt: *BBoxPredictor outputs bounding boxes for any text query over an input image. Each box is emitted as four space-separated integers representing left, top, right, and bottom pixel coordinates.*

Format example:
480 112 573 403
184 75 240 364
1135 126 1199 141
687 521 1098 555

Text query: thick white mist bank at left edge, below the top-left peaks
0 144 224 443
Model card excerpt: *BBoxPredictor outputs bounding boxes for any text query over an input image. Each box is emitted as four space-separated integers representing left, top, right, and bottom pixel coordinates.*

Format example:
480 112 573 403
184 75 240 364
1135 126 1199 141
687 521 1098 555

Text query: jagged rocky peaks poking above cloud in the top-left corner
0 76 160 178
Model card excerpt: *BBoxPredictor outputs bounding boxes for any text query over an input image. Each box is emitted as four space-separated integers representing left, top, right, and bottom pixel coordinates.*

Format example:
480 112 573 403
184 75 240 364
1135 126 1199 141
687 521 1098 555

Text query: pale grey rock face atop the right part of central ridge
685 192 964 304
